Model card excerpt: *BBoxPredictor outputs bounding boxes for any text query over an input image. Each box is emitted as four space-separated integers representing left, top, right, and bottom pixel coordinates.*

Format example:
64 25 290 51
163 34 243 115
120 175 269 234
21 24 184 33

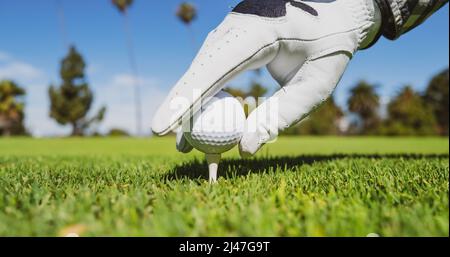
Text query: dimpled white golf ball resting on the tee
182 91 246 154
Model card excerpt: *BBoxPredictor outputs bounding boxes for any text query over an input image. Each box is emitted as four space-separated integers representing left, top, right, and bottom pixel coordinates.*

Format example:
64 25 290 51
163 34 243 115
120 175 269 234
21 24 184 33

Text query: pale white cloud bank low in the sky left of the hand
0 52 167 137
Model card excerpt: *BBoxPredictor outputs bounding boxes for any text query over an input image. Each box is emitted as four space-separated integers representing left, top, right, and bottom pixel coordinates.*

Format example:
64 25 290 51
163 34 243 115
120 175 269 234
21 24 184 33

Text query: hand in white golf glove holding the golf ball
152 0 381 157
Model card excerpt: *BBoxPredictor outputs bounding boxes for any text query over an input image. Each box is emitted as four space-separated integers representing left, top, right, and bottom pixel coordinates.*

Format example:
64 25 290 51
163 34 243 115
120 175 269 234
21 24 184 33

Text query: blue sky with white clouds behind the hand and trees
0 0 449 136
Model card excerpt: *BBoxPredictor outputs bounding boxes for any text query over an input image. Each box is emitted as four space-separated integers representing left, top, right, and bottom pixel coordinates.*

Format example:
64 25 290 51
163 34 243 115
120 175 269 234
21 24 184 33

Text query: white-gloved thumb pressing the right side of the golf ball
239 52 350 157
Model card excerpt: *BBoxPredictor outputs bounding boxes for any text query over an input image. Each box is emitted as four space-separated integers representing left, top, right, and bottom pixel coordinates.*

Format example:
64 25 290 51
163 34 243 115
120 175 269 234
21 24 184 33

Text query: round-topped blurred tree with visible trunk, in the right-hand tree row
348 81 380 133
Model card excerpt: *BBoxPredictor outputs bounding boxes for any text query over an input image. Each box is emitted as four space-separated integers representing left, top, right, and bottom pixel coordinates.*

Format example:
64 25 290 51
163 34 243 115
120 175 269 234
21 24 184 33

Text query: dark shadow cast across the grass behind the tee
164 154 449 180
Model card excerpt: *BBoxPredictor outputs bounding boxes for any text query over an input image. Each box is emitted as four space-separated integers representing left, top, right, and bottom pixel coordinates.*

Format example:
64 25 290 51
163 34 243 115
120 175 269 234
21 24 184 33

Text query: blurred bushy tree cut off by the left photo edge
0 80 25 136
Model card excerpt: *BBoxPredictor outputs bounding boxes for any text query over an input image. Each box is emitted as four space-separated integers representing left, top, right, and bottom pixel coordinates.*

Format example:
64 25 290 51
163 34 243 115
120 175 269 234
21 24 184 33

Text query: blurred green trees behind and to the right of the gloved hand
226 68 449 136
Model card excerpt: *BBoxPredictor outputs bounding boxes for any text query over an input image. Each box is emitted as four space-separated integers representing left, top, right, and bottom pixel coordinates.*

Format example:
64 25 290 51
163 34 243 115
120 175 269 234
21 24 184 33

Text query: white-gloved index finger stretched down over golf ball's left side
152 13 278 135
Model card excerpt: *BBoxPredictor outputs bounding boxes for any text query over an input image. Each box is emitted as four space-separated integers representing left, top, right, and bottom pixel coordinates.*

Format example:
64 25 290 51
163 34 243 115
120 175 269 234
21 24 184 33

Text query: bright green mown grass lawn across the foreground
0 137 449 236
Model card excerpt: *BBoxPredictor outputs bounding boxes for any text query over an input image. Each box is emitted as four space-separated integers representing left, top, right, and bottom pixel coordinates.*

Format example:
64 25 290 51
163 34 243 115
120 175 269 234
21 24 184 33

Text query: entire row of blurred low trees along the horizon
0 47 449 136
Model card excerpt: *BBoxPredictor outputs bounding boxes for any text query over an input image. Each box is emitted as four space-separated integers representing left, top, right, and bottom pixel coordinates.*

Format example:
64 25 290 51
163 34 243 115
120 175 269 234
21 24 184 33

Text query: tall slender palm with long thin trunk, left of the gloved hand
112 0 142 135
